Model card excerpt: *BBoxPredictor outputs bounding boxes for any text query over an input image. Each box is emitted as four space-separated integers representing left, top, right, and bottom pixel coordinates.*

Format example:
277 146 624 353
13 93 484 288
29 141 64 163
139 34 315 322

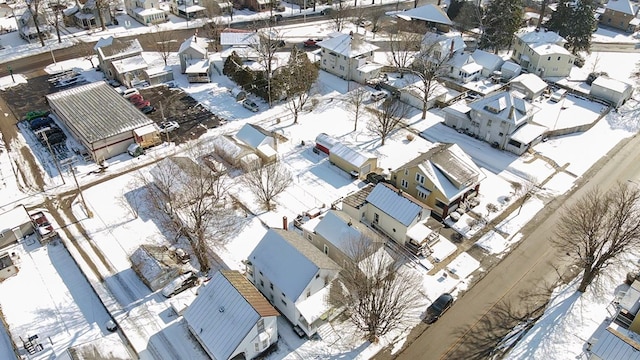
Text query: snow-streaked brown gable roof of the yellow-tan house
400 143 482 200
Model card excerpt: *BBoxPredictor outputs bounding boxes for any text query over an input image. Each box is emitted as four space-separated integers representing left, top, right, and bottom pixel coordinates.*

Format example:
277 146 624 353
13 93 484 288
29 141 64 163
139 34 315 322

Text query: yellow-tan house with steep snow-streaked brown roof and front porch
391 143 484 219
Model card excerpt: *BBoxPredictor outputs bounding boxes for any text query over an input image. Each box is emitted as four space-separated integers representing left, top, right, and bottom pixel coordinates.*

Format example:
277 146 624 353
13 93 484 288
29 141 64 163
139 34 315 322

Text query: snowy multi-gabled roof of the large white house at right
469 91 538 126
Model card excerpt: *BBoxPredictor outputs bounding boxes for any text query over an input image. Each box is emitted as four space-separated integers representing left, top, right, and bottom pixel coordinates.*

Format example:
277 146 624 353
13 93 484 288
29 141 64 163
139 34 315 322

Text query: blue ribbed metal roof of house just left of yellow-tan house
367 183 428 226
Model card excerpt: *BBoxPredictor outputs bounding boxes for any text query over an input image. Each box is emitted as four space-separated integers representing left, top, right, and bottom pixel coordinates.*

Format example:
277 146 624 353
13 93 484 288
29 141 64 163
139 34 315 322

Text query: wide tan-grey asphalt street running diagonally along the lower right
384 136 640 359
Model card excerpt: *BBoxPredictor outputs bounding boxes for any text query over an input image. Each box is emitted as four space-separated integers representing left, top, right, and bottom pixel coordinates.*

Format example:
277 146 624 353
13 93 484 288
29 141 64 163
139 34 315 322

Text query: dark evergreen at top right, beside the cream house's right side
546 0 596 55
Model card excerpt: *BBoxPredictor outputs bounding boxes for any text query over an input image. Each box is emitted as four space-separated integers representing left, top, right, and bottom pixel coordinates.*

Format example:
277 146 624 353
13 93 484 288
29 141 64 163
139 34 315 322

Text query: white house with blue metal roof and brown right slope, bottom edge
183 270 280 360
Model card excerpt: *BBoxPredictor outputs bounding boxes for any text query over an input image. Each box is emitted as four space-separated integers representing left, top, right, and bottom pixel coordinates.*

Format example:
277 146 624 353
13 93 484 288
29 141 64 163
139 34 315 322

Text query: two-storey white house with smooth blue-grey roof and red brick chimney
246 229 340 336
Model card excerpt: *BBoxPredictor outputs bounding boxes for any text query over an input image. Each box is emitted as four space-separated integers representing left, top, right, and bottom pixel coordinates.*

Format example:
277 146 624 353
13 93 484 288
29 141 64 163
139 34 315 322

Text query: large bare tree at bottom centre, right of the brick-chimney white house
329 239 422 343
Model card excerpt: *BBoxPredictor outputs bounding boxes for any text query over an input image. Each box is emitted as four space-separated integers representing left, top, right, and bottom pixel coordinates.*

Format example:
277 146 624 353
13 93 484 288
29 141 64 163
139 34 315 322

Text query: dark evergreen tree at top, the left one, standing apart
480 0 524 53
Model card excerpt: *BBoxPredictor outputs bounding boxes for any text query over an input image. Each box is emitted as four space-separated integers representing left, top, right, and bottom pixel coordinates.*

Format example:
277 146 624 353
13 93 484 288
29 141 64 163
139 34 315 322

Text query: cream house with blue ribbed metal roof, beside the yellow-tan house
342 182 431 245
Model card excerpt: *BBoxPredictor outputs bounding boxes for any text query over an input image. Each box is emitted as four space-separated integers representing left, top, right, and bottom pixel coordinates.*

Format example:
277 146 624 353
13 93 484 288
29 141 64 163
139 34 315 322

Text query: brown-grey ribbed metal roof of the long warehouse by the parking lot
47 81 153 143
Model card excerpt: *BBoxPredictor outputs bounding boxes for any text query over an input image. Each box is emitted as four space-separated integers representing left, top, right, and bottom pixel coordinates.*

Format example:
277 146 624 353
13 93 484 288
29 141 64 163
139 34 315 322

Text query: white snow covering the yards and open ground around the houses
0 1 640 359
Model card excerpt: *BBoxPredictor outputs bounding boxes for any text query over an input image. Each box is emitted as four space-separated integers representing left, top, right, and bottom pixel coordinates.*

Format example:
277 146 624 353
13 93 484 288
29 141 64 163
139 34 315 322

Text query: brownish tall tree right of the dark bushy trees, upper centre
277 46 319 124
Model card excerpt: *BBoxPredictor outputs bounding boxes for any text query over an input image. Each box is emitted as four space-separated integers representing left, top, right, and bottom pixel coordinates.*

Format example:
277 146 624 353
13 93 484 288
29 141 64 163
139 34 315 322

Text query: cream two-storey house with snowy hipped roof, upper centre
316 33 383 84
